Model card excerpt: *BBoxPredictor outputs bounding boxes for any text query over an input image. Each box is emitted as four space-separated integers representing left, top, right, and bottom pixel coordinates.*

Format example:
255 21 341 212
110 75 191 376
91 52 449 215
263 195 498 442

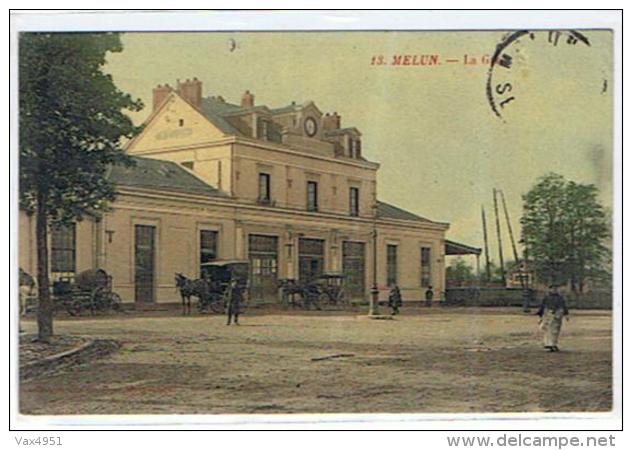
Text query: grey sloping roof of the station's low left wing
108 156 227 197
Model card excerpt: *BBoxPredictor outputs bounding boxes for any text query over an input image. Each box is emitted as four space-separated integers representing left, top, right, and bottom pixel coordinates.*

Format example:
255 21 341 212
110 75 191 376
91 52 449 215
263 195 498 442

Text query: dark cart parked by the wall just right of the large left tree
53 269 121 316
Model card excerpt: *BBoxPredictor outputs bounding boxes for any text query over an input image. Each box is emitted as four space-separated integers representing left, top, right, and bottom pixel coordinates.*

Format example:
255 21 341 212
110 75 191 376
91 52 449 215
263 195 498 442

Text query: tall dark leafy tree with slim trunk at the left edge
19 33 143 341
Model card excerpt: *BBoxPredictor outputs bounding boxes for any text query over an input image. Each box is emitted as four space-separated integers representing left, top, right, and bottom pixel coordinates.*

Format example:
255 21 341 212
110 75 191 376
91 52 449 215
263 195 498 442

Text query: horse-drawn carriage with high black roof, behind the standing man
176 260 250 313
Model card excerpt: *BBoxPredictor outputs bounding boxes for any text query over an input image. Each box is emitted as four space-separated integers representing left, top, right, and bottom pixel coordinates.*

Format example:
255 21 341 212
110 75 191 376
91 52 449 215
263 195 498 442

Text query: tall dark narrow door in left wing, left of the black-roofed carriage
134 225 156 303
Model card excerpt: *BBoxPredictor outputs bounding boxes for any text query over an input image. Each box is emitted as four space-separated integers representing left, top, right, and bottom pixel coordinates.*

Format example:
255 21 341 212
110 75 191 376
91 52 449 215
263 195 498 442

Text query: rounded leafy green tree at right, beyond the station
520 174 610 292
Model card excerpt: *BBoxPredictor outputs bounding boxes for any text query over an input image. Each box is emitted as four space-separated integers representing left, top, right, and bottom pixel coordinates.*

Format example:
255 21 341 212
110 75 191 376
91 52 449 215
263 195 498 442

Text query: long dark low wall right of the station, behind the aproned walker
445 287 612 309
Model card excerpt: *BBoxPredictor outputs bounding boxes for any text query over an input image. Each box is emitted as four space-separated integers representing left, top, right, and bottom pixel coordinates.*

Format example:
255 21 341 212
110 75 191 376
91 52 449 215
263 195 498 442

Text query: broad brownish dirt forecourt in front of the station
20 308 612 414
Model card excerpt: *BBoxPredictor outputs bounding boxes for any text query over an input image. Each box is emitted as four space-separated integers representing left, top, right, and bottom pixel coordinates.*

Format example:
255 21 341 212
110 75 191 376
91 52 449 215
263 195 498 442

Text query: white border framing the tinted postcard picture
4 10 622 430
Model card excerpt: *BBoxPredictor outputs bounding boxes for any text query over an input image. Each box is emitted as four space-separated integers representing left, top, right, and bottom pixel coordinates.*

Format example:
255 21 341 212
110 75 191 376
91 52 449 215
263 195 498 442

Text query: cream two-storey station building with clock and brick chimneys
19 78 476 306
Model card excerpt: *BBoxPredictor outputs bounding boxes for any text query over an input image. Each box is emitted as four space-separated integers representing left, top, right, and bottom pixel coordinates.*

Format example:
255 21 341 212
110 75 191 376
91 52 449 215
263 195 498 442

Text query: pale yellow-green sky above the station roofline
105 30 613 261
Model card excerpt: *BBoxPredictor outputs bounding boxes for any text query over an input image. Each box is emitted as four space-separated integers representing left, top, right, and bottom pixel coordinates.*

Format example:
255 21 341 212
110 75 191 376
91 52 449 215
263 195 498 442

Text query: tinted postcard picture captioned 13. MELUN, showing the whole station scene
12 12 621 432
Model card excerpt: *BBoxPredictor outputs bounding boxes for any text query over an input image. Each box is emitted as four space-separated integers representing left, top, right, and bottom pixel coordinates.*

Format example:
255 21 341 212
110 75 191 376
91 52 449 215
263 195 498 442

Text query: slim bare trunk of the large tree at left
35 192 53 342
